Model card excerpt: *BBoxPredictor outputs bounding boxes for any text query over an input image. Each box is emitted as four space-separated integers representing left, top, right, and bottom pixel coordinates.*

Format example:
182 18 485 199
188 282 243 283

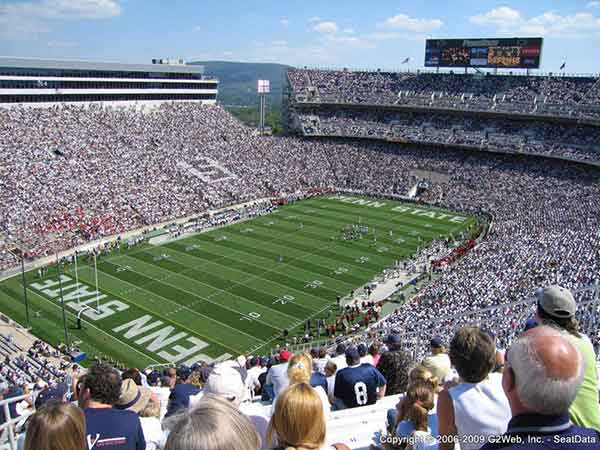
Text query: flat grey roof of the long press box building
0 56 204 74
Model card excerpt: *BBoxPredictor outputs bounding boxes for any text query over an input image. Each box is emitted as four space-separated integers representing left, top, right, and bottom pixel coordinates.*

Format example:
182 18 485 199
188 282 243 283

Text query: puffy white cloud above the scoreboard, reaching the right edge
470 7 600 38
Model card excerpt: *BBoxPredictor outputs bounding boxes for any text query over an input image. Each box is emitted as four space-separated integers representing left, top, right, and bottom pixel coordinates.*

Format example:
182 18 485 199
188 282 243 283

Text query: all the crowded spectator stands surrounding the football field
0 70 600 450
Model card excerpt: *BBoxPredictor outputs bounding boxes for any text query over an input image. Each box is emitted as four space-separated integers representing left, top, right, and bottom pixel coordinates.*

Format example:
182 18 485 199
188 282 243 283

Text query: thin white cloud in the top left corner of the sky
0 0 121 39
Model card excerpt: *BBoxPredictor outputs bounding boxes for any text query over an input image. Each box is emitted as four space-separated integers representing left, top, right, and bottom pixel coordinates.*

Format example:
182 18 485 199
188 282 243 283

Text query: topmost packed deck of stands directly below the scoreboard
288 69 600 119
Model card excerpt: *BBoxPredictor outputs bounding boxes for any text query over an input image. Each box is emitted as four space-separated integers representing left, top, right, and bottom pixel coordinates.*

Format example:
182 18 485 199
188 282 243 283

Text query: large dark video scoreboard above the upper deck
425 38 544 69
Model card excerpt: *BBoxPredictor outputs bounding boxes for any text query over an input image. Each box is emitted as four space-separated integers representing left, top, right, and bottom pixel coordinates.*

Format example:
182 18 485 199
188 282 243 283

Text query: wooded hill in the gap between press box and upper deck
188 61 288 108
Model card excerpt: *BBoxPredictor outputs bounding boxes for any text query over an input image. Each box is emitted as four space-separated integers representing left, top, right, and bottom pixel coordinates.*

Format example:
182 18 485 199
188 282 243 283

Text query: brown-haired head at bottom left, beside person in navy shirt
24 401 85 450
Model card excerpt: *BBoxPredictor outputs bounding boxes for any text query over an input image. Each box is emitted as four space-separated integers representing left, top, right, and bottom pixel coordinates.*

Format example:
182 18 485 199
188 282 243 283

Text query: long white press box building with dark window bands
0 57 219 107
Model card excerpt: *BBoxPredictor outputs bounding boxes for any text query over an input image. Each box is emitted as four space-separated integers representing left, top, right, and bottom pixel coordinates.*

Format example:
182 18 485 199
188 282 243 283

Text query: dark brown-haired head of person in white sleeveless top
449 326 496 383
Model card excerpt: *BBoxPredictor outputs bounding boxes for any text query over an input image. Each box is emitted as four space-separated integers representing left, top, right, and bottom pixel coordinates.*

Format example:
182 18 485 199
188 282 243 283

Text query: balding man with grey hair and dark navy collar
481 326 600 450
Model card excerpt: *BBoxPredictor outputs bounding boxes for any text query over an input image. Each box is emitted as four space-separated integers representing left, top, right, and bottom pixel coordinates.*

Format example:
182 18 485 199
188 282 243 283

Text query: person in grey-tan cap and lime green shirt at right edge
536 286 600 431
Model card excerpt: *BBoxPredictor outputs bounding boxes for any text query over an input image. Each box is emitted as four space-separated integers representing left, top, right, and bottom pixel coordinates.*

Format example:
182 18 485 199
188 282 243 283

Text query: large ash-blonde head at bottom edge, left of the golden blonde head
165 395 261 450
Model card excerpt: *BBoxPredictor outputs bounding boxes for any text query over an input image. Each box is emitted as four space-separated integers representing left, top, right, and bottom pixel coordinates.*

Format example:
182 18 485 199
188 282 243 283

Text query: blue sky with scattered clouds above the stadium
0 0 600 73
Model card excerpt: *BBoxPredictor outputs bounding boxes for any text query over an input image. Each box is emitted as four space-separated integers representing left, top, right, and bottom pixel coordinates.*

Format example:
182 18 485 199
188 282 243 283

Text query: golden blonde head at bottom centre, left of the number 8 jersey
267 383 325 450
